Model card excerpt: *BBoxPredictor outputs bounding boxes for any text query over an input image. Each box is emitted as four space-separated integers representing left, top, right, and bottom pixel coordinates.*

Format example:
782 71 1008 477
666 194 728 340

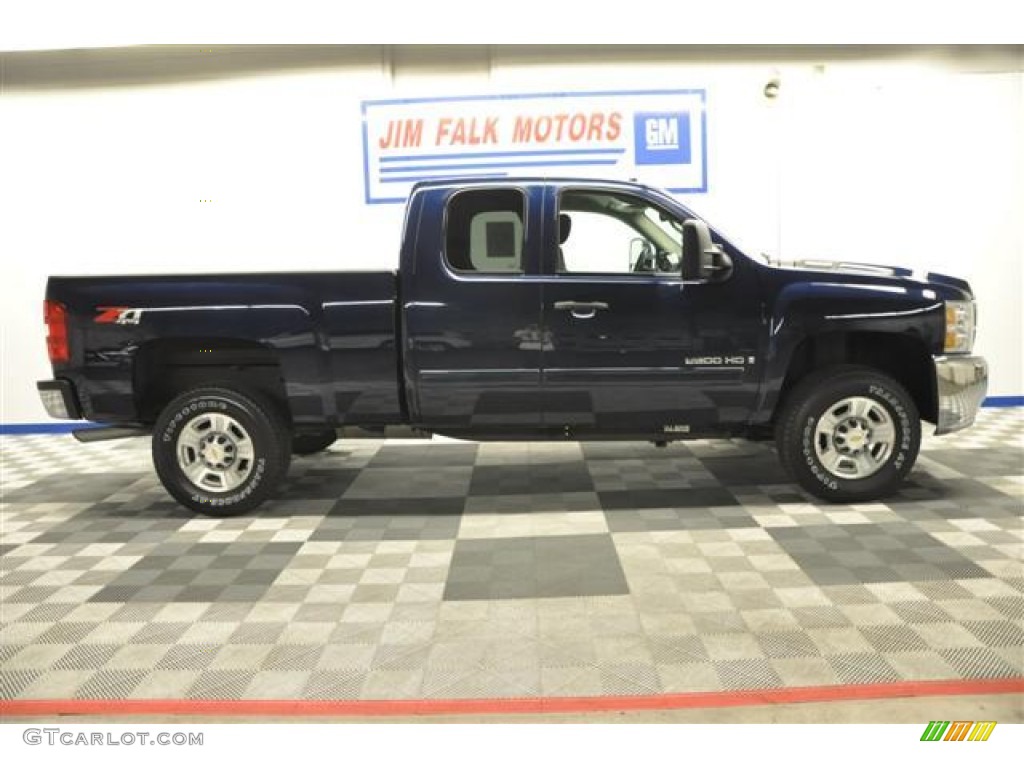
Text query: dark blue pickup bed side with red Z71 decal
47 271 408 426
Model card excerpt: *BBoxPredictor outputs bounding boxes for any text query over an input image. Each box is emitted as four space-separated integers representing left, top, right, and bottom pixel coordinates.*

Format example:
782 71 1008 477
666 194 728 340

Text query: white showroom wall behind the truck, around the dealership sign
0 48 1024 423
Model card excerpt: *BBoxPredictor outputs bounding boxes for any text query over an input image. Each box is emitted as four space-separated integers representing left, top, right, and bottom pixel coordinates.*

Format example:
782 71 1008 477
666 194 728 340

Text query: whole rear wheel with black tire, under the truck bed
153 386 291 517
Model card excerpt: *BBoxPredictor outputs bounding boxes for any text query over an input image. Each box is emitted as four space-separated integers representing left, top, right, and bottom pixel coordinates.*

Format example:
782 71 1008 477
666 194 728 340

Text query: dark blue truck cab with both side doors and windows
399 181 765 438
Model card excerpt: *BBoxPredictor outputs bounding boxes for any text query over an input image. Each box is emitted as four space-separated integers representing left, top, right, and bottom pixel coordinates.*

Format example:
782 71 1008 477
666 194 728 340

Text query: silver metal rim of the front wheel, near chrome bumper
814 397 896 480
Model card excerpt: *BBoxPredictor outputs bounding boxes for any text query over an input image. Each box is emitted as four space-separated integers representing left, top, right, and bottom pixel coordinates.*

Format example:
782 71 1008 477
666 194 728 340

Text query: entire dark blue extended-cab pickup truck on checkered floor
39 178 987 515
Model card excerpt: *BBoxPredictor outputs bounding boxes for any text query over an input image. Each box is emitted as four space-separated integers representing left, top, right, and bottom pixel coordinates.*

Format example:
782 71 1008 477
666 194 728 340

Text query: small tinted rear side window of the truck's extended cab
444 189 524 274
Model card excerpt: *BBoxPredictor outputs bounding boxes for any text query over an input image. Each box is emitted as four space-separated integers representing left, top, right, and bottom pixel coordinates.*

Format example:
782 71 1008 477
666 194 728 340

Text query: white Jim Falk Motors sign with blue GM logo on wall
362 90 708 203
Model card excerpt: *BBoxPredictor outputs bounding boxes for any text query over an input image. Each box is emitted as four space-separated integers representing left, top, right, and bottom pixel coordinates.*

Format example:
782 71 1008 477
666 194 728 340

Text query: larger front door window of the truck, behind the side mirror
557 191 682 274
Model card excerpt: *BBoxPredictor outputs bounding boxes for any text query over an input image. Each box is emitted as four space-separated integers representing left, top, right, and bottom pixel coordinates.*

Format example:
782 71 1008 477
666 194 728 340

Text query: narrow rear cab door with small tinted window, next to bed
401 184 543 434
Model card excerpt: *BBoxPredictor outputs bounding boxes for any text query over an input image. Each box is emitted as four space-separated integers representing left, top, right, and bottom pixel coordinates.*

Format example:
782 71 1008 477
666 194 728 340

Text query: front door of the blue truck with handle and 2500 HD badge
543 188 762 436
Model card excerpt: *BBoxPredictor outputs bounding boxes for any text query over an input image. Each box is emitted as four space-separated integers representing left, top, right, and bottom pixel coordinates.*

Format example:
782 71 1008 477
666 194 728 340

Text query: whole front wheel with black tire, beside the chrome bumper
775 366 921 503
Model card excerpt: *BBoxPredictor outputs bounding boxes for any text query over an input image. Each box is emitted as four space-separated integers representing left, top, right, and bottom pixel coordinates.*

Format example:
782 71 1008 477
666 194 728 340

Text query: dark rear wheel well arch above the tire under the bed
132 337 291 424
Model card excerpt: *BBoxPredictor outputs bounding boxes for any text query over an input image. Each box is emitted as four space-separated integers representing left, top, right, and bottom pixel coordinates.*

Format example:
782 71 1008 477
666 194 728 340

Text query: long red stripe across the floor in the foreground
0 678 1024 717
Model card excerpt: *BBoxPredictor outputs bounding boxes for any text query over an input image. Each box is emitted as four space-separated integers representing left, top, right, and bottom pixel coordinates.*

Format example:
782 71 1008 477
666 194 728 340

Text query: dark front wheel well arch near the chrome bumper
773 331 938 423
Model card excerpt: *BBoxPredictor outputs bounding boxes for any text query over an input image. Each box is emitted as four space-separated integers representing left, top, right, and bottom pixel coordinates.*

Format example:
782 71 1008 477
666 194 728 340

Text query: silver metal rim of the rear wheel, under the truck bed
175 414 256 494
